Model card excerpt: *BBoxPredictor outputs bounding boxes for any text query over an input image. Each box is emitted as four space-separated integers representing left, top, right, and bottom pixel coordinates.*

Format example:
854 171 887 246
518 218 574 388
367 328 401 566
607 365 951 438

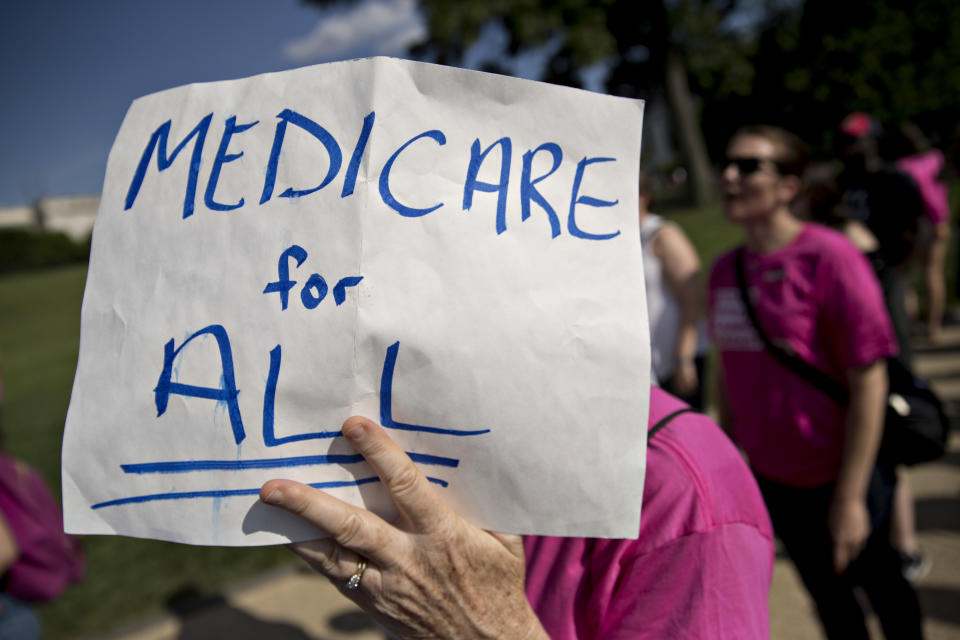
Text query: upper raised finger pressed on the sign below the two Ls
343 416 448 532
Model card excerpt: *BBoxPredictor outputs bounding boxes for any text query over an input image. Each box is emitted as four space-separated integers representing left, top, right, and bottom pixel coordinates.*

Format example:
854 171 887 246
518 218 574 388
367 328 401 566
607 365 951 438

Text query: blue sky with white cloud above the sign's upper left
0 0 425 206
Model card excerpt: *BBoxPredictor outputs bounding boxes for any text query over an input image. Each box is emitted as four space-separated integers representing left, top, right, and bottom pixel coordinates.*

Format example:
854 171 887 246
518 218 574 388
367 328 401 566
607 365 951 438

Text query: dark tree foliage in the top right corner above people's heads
704 0 960 154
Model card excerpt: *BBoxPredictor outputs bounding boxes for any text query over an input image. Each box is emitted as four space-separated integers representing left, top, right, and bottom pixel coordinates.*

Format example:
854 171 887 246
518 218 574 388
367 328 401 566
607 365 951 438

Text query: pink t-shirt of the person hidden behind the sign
524 388 774 640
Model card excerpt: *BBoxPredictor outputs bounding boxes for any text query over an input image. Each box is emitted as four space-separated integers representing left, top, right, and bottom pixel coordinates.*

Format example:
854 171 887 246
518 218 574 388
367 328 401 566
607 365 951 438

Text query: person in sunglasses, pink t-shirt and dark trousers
708 126 923 640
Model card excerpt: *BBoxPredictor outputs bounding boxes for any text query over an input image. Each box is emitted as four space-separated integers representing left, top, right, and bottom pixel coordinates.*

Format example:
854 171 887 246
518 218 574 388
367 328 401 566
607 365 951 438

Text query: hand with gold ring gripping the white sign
260 417 547 638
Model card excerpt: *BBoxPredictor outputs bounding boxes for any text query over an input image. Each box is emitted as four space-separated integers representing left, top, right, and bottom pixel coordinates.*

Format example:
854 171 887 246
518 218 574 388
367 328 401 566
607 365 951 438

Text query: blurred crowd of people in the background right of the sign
639 112 950 638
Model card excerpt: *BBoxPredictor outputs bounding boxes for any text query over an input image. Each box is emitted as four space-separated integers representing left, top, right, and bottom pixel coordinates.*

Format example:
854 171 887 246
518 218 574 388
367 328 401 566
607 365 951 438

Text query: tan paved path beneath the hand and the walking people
108 327 960 640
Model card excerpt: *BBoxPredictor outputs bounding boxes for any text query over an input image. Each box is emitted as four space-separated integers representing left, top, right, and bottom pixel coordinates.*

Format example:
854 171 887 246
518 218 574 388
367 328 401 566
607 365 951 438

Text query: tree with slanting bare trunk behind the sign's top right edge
312 0 750 204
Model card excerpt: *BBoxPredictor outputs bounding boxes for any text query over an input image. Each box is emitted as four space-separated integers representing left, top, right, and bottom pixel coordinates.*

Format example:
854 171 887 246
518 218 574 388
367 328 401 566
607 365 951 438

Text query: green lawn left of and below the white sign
0 265 293 639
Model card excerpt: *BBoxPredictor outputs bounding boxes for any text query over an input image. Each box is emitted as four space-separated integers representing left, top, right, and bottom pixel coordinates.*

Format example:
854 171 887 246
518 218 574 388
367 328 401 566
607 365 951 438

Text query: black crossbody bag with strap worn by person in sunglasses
735 248 950 465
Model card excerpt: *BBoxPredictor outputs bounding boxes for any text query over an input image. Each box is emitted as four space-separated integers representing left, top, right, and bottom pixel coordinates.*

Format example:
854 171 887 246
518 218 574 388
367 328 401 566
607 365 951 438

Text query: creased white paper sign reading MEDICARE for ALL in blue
63 58 650 545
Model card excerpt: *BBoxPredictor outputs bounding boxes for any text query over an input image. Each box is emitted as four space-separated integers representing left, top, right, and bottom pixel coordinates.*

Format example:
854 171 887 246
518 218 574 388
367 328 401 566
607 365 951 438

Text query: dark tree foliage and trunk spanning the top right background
308 0 960 180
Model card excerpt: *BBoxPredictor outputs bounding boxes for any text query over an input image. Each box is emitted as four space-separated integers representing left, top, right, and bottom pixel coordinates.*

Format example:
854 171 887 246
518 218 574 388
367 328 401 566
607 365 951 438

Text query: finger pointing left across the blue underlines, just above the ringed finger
260 480 406 565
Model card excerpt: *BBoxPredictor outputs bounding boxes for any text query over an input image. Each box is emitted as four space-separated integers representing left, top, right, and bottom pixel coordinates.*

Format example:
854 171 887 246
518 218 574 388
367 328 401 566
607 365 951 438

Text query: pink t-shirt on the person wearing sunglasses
709 224 897 487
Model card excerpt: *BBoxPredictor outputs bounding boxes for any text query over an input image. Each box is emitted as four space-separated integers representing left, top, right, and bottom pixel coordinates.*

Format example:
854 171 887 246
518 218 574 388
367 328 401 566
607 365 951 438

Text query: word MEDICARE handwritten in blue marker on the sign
124 109 620 240
